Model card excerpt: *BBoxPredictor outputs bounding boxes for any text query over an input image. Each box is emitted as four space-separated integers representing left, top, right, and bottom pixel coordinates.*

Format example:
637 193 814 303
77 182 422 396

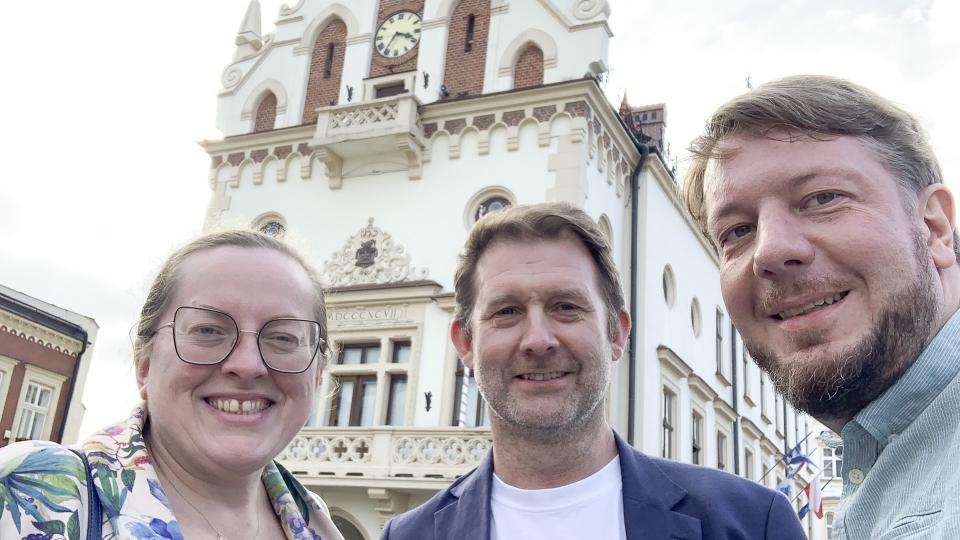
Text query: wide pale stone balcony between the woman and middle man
277 427 493 489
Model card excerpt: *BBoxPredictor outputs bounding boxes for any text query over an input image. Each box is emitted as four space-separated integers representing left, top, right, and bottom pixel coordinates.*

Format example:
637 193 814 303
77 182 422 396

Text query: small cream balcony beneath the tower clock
310 94 425 189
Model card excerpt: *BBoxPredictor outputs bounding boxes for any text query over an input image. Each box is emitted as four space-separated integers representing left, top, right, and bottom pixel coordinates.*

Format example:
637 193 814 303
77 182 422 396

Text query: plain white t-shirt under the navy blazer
490 456 627 540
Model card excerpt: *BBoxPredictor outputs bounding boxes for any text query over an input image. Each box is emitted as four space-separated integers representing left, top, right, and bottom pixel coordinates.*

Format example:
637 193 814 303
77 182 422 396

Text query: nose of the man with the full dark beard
753 208 814 279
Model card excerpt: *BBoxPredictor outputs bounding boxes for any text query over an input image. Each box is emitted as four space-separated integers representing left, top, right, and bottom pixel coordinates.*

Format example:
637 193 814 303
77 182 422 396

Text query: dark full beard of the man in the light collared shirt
744 233 940 420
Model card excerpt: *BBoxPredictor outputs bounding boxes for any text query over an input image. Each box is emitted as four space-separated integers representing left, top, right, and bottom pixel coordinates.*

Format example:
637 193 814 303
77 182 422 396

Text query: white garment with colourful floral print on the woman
0 405 342 540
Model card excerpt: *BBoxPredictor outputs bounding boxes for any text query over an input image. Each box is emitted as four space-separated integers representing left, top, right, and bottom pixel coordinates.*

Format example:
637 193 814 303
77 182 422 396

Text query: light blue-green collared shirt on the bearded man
833 311 960 540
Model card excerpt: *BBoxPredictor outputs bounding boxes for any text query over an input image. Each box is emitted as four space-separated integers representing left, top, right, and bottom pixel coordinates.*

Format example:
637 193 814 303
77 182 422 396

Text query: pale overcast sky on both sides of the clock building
0 0 960 442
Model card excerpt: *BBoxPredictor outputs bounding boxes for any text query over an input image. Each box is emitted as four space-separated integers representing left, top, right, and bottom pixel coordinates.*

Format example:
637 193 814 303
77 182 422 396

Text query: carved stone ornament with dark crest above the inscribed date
323 218 428 287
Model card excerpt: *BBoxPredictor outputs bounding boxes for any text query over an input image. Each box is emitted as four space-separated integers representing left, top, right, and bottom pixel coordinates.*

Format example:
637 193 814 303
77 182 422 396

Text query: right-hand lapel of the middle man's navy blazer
614 433 701 540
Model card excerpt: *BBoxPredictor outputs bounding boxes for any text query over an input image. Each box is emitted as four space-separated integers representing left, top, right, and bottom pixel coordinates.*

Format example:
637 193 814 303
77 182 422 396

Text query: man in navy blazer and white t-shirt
383 204 805 540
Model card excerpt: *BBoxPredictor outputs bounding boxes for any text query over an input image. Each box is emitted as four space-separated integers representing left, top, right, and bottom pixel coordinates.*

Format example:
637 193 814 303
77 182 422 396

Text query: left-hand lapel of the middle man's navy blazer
433 450 493 540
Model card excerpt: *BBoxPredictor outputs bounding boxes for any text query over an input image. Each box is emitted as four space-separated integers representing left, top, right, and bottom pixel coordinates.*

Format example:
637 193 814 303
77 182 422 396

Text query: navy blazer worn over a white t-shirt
381 434 806 540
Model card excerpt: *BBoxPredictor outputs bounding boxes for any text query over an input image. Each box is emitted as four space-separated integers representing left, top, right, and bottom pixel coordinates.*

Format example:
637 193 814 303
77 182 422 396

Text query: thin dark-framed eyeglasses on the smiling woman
154 306 324 373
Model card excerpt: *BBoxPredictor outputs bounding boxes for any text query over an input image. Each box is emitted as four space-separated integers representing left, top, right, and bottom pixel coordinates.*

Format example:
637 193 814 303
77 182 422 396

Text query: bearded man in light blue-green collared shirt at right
684 76 960 540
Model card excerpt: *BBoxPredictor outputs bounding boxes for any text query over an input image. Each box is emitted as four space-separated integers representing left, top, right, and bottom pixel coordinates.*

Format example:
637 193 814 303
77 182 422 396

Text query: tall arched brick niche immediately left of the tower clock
303 19 347 124
